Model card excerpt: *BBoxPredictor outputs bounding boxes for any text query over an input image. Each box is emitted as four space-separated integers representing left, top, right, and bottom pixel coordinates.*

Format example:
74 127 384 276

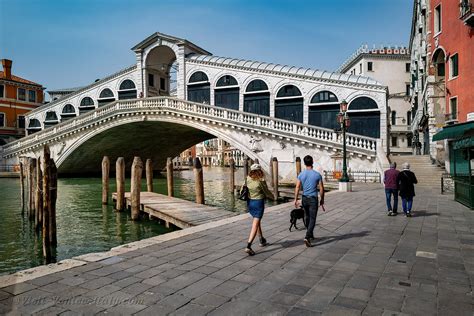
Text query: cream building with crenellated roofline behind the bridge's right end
338 45 413 155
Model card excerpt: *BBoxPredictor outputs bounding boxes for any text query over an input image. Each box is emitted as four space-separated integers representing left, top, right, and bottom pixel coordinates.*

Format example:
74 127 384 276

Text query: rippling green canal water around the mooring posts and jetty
0 167 272 275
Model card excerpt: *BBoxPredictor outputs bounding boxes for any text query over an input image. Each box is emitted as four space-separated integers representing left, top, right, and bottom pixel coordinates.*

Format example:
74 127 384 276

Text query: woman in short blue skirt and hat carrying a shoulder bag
245 164 275 256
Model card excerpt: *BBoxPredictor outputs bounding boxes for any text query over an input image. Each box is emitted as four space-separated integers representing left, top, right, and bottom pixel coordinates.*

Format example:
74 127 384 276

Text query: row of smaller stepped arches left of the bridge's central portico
27 79 137 133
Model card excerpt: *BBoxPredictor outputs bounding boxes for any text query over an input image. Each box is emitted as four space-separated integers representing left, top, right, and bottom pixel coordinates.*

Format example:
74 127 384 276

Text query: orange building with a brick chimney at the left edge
0 59 44 146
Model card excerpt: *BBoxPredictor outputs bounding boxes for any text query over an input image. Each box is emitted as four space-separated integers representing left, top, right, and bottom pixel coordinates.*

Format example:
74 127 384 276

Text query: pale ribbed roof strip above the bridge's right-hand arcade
187 55 385 87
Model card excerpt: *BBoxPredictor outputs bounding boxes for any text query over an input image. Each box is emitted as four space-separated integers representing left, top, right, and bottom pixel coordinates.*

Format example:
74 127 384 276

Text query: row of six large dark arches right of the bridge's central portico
187 71 380 138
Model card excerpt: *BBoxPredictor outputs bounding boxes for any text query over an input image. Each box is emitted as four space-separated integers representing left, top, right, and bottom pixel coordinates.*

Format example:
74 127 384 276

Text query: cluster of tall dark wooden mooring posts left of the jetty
20 145 58 263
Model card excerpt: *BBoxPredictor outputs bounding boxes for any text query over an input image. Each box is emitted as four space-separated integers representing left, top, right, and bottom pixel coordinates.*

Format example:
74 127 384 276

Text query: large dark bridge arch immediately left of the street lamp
308 91 339 129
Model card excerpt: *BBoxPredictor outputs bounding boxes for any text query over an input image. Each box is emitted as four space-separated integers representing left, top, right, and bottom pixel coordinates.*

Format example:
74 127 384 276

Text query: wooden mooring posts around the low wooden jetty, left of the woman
102 156 204 220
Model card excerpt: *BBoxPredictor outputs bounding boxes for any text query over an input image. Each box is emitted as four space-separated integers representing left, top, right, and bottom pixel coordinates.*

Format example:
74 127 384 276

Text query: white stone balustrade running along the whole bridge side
3 97 377 157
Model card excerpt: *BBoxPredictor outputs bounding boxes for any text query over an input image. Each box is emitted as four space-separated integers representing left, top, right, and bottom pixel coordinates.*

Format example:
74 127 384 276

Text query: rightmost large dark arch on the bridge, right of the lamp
348 97 380 138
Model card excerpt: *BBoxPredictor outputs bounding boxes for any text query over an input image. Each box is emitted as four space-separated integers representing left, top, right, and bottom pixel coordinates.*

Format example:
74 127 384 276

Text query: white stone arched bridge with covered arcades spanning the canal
2 33 387 180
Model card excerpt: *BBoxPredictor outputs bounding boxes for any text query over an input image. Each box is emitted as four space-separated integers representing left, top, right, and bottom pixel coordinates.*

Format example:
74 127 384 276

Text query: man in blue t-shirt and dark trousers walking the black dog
295 155 324 247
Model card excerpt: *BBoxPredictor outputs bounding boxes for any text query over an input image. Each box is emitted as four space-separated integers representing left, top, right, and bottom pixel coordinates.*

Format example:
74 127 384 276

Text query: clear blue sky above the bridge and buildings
0 0 413 89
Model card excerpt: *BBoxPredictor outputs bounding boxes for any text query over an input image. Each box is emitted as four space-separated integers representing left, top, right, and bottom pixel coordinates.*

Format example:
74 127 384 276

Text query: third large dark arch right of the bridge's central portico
244 79 270 116
